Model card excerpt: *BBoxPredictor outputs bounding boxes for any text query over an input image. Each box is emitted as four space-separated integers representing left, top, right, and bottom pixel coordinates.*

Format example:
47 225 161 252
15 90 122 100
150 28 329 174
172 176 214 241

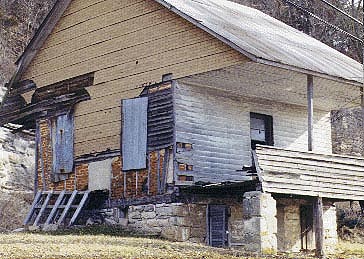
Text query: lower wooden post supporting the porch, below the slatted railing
313 197 325 258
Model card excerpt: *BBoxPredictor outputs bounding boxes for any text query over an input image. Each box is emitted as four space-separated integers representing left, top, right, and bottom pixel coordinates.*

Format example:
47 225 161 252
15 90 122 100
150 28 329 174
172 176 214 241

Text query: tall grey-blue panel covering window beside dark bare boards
122 97 148 171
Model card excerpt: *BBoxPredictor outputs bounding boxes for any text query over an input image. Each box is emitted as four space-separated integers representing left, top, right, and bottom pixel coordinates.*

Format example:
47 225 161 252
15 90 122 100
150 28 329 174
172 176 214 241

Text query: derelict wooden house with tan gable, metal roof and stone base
0 0 364 252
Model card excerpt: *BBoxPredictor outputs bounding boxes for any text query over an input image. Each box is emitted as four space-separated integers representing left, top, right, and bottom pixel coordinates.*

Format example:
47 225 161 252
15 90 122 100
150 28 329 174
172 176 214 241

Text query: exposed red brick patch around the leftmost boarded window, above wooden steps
38 120 88 191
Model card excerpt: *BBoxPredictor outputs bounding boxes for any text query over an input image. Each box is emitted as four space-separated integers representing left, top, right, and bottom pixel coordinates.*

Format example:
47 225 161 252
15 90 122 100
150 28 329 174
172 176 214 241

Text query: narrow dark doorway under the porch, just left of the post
300 205 315 251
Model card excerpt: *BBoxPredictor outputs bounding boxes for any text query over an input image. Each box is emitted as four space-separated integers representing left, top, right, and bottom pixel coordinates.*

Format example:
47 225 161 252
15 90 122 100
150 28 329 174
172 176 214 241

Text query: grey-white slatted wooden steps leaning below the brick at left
23 190 90 230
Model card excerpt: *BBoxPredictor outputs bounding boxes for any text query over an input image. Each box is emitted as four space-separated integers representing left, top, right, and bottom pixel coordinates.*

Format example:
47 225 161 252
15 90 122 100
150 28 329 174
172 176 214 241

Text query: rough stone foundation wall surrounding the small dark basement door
126 200 244 246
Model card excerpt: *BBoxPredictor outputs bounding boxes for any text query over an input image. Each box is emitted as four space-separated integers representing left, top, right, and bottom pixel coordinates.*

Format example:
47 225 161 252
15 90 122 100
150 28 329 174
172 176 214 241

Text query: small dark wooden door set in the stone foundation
208 205 228 247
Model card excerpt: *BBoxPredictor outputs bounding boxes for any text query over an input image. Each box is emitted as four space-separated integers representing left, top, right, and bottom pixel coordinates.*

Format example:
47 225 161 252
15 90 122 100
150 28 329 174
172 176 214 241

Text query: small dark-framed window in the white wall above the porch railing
250 113 274 149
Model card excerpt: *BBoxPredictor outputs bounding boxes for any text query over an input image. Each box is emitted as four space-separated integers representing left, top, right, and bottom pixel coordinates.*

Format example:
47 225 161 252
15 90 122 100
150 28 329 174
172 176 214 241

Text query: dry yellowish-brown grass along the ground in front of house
0 233 364 259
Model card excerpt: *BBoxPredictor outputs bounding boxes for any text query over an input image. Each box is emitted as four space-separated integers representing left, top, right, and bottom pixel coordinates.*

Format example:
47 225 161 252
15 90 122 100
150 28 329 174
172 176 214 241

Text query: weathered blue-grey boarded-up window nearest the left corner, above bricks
51 113 73 182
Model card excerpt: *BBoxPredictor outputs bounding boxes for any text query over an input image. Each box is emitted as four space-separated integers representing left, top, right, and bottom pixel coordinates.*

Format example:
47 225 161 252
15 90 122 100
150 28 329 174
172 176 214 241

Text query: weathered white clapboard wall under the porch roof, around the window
175 80 332 182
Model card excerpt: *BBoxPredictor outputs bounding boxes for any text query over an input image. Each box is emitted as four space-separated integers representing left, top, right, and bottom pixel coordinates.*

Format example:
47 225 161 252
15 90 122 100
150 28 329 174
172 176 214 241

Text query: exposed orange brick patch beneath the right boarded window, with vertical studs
111 150 165 199
